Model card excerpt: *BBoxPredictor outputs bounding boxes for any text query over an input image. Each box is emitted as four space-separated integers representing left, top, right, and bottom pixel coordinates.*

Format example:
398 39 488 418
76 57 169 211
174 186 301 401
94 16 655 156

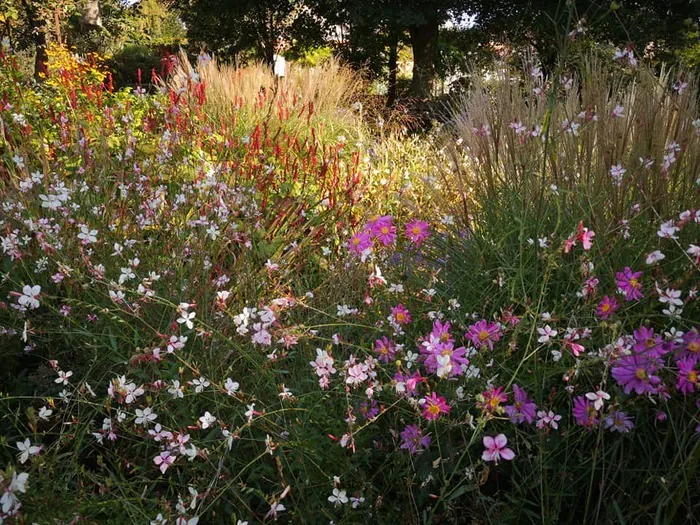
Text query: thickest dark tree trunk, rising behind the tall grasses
408 12 439 98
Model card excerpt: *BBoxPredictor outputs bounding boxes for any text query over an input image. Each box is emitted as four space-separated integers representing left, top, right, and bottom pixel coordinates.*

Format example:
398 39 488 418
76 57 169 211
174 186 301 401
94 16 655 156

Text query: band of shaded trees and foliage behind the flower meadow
5 0 700 95
